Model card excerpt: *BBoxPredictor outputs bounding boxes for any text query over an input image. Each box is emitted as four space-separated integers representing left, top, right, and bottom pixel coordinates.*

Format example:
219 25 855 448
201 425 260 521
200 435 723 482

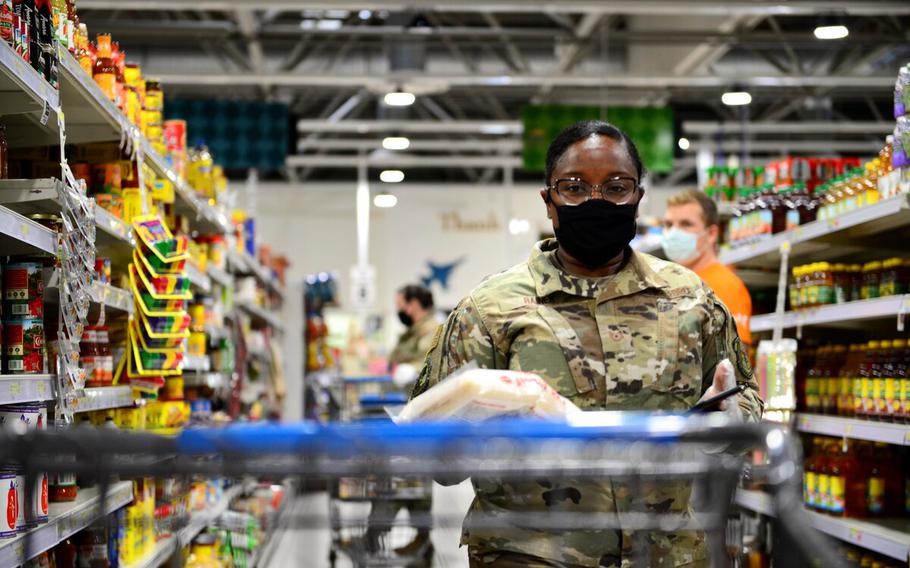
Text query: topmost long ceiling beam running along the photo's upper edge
79 0 910 16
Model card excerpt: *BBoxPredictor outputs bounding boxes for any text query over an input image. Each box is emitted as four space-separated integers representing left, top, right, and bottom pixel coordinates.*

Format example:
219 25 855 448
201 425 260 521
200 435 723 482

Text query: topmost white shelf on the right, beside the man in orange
719 195 910 268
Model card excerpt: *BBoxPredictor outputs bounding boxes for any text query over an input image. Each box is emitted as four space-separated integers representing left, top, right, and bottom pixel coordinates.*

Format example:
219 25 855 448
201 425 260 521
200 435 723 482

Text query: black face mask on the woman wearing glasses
554 199 638 268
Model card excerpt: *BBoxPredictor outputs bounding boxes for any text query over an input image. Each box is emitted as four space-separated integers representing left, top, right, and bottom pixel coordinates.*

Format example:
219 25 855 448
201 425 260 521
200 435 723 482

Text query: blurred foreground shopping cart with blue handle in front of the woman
0 412 843 567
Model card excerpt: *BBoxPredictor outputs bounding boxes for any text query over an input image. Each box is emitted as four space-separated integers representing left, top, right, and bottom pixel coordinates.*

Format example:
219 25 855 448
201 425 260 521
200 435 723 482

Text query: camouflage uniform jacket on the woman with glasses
412 239 762 567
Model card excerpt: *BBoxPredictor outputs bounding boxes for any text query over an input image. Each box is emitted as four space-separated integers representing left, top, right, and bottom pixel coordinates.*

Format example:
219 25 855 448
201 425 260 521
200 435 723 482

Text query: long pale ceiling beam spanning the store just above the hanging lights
159 72 894 92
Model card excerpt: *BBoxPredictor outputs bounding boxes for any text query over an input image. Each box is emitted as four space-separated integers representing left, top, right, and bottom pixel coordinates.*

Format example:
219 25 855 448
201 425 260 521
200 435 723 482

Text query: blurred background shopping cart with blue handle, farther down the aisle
329 375 433 567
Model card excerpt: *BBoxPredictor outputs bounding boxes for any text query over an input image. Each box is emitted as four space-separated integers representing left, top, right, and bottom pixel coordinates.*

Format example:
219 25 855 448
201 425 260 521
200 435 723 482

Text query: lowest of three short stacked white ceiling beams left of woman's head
285 154 523 168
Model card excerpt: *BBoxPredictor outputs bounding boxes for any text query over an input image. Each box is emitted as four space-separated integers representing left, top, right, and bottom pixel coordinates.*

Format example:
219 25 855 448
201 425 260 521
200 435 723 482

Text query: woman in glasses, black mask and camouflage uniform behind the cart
412 121 762 568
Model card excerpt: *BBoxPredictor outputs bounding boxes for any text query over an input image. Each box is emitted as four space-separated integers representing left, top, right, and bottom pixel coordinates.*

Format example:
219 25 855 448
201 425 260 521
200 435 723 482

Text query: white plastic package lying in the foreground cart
396 369 581 422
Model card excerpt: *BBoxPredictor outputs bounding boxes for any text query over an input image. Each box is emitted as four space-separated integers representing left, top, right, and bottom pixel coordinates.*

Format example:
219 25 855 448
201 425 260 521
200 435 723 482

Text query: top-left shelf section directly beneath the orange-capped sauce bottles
57 48 128 144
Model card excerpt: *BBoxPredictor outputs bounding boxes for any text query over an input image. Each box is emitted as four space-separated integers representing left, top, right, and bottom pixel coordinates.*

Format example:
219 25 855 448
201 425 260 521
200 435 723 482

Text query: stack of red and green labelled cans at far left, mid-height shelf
2 262 47 375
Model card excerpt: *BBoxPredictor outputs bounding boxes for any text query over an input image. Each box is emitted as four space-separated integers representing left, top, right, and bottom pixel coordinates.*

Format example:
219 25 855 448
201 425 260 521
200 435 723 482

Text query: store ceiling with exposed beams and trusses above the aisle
79 0 910 184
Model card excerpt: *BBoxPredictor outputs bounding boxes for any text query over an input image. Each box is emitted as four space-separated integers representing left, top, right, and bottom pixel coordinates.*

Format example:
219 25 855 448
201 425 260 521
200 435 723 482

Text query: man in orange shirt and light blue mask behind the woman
661 190 752 344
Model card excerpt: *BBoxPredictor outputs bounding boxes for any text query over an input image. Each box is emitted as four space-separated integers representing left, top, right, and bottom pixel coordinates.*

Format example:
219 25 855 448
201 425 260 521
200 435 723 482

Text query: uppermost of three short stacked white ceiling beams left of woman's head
297 120 524 135
